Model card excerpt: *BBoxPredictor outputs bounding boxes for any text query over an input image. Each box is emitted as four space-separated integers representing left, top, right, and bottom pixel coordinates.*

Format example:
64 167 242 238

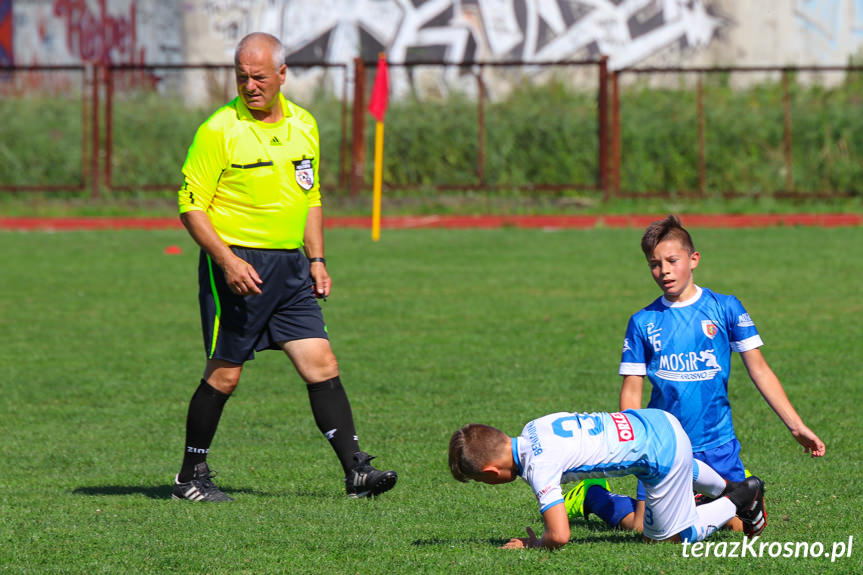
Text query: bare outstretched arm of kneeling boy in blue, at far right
740 348 826 457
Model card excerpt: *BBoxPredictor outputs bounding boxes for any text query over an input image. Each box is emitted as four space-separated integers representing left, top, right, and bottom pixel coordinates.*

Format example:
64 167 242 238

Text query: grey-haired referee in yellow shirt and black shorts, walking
173 33 397 501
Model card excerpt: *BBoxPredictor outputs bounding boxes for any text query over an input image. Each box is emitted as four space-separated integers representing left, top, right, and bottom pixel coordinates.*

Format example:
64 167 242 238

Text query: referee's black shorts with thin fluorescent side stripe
198 246 329 364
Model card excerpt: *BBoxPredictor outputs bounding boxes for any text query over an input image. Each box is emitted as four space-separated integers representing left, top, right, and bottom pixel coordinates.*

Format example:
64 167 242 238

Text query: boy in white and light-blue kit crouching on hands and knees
449 409 764 549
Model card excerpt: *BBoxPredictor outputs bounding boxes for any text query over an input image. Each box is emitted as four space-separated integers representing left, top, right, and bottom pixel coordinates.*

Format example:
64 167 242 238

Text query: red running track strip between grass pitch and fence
0 214 863 231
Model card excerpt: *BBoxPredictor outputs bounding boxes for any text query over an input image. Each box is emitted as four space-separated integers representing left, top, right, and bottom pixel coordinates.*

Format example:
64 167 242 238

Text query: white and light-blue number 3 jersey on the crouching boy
512 409 680 513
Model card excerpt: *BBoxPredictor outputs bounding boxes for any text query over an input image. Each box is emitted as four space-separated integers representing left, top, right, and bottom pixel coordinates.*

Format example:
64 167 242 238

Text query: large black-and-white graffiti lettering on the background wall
182 0 727 68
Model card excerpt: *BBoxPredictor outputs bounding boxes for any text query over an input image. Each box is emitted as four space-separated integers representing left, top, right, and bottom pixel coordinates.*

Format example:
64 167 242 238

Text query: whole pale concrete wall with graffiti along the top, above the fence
5 0 863 69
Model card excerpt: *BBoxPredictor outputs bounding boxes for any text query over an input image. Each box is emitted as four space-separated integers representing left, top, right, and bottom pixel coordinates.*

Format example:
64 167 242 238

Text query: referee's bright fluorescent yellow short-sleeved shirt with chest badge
179 94 321 249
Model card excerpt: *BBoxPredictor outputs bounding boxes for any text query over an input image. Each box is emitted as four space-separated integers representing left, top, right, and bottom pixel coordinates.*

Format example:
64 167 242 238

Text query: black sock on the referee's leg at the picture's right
307 376 360 476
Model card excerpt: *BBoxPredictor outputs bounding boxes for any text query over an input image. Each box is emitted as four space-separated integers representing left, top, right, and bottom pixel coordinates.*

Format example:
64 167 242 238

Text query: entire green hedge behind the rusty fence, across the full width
0 74 863 196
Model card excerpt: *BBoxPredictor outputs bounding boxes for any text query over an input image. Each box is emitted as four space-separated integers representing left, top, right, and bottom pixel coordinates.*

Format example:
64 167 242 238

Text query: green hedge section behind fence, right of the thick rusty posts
621 76 863 196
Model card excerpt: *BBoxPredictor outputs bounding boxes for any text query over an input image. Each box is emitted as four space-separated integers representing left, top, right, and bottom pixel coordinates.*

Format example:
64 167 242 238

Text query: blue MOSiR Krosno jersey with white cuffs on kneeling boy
619 286 762 451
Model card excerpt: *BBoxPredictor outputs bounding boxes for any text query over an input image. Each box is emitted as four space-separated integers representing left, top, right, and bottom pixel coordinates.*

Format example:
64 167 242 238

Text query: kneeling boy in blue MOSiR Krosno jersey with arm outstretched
568 215 825 536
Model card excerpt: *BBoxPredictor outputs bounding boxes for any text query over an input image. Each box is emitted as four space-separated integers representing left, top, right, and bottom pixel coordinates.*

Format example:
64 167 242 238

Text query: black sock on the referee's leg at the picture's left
179 379 231 483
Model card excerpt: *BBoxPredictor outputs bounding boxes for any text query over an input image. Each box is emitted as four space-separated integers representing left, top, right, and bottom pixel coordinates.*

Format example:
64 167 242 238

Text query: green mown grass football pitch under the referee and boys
0 228 863 574
